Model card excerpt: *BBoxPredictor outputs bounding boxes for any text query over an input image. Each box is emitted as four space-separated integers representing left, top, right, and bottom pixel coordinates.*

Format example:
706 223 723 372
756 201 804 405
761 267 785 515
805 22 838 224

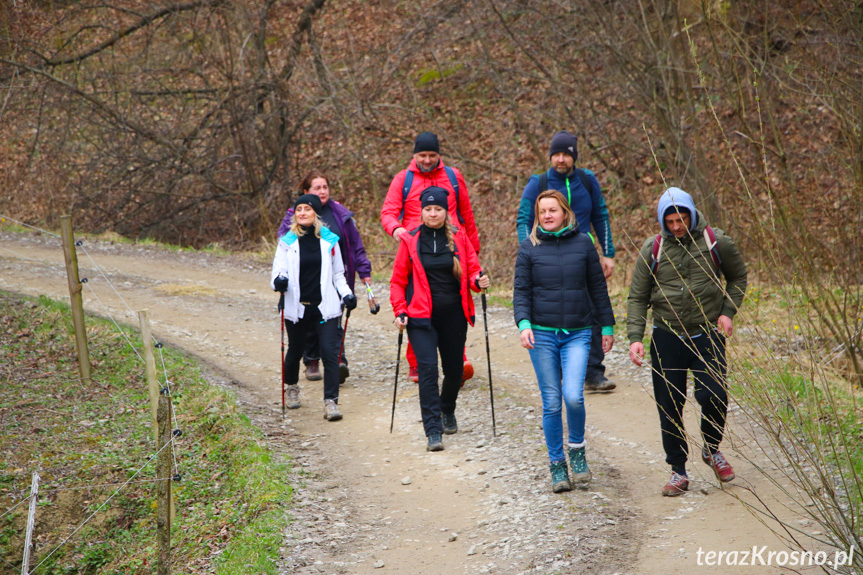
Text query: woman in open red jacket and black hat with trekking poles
390 186 489 451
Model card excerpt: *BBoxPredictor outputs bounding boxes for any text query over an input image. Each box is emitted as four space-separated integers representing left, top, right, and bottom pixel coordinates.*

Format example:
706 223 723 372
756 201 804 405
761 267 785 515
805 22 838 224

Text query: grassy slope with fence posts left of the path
0 292 292 575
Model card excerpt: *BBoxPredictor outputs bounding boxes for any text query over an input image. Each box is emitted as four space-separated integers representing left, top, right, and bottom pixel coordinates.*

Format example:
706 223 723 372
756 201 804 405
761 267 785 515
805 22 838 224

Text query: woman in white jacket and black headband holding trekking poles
270 194 357 421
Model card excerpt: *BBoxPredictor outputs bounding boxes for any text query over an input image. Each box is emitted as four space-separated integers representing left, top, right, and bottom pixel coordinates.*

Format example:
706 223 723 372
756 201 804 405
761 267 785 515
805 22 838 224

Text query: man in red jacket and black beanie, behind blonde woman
381 132 479 381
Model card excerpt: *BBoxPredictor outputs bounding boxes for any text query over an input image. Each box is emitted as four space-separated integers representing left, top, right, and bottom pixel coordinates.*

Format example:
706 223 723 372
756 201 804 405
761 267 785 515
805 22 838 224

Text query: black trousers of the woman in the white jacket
285 305 342 403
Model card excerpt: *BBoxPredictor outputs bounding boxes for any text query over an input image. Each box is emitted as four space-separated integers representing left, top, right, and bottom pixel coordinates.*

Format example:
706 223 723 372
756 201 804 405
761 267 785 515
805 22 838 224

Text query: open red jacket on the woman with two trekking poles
390 227 481 325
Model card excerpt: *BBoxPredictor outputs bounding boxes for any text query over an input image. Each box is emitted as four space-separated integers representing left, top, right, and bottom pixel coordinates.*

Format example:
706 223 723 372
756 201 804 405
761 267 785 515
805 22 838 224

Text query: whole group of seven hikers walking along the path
271 131 747 496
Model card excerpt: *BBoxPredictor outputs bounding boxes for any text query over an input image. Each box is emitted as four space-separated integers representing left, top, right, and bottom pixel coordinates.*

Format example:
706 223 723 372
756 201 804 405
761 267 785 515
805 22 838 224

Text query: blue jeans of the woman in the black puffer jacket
530 329 590 462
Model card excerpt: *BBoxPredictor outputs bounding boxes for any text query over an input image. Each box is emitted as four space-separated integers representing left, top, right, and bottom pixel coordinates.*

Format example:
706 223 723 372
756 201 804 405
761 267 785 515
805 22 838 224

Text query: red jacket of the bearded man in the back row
381 159 479 253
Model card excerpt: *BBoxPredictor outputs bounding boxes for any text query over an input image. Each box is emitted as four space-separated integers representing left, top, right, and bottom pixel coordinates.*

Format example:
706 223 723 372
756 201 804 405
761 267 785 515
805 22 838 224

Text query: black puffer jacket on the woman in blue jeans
512 227 614 329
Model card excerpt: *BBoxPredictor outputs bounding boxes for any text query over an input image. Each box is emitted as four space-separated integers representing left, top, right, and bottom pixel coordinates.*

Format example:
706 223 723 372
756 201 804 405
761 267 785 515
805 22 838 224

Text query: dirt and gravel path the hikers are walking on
0 233 802 574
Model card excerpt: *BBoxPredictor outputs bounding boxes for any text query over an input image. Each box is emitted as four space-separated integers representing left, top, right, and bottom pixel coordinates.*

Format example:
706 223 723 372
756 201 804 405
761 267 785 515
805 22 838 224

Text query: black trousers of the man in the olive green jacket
650 328 728 468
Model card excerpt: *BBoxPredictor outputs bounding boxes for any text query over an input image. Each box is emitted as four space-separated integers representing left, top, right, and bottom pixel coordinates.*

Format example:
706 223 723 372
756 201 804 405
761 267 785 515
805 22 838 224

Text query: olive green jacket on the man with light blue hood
626 212 747 343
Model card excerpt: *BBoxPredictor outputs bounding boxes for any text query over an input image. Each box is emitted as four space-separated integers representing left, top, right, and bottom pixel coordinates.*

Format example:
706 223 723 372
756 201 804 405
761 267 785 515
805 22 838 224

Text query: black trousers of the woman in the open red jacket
407 302 467 435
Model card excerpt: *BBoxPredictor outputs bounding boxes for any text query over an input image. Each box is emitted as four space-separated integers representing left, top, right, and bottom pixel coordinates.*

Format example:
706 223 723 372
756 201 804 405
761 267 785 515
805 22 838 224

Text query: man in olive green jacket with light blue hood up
626 188 747 497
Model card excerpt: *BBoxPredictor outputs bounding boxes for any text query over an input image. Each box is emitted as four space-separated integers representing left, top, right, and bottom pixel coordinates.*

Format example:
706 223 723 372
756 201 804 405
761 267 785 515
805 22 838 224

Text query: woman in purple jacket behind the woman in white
278 170 372 383
